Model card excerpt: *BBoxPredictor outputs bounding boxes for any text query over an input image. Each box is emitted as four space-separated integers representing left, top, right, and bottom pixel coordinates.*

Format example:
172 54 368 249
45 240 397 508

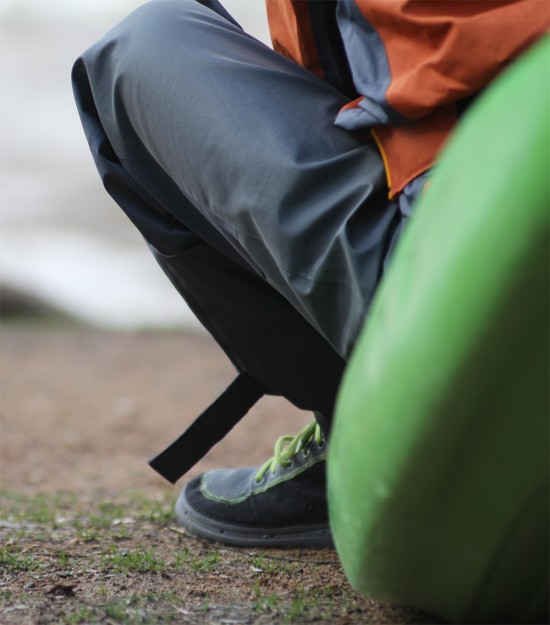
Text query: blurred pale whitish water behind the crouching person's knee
0 0 269 330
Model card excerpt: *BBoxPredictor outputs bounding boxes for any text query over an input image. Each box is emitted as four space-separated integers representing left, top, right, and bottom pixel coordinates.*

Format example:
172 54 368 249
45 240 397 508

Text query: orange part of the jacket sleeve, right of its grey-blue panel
356 0 550 119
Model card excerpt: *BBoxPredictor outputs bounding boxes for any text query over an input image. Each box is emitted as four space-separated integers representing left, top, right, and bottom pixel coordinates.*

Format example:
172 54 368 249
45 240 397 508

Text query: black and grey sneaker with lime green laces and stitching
176 422 333 548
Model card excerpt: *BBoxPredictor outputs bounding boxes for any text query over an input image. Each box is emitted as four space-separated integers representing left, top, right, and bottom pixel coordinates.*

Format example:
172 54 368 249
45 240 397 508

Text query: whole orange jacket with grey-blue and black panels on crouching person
267 0 550 197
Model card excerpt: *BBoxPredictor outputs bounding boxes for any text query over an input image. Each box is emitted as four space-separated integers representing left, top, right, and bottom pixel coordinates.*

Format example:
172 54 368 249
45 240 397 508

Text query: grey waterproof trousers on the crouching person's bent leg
73 0 418 426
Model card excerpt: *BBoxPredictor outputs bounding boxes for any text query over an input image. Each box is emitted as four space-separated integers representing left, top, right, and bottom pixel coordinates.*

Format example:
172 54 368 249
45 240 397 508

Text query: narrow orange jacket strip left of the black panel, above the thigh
266 0 323 78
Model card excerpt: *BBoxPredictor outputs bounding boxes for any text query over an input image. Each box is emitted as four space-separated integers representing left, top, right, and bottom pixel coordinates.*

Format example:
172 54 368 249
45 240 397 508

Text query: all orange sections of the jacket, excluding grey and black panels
266 0 550 197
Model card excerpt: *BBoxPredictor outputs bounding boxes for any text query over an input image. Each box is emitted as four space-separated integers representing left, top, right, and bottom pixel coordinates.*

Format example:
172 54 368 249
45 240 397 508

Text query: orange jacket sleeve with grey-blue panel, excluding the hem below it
337 0 550 128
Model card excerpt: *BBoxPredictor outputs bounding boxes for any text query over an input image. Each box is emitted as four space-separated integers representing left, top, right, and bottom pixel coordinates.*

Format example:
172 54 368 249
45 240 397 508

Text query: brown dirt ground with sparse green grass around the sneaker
0 321 440 625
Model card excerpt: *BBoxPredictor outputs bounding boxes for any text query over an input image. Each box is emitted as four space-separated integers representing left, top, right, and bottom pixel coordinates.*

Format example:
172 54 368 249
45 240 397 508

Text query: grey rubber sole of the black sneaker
176 489 334 549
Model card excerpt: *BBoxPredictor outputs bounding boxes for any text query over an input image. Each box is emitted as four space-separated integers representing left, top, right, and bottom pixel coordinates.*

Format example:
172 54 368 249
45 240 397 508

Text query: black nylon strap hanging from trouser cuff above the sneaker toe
149 373 266 484
